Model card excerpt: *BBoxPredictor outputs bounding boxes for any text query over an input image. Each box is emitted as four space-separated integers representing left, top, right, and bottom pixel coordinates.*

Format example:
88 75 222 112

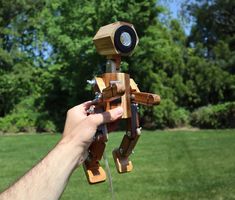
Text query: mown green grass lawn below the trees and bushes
0 130 235 200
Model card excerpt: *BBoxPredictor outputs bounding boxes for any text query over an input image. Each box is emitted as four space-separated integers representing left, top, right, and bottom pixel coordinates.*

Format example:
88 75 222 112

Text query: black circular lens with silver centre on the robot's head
114 25 137 54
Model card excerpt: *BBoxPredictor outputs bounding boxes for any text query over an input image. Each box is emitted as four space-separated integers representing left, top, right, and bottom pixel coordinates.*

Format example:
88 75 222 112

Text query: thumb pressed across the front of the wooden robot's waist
90 107 123 126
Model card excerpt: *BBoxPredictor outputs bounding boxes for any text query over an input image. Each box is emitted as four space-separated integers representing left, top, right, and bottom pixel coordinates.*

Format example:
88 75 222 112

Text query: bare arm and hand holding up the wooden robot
0 101 123 200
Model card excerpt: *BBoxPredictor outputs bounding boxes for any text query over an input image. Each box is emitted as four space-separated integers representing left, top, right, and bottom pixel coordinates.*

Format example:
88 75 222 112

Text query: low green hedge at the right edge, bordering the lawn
190 102 235 128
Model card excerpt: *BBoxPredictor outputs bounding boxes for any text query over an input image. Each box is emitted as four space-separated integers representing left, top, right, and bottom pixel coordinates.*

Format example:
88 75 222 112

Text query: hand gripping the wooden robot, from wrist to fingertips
61 101 123 161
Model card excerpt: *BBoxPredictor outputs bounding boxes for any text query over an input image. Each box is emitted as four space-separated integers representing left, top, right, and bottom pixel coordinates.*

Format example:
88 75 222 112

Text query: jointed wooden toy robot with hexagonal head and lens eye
83 22 160 184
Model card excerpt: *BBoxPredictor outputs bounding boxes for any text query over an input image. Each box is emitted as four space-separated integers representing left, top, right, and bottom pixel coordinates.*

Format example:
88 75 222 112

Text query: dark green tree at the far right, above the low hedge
185 0 235 108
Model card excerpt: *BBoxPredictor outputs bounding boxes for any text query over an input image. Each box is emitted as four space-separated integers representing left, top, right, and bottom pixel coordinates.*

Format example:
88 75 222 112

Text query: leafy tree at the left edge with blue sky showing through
0 0 46 117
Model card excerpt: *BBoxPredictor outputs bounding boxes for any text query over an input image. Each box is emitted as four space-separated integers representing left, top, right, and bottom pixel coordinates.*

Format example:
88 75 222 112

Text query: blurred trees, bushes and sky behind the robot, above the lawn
0 0 235 134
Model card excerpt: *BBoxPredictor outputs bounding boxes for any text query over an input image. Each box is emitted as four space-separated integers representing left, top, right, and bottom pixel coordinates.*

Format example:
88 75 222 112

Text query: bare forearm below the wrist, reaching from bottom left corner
0 138 84 200
